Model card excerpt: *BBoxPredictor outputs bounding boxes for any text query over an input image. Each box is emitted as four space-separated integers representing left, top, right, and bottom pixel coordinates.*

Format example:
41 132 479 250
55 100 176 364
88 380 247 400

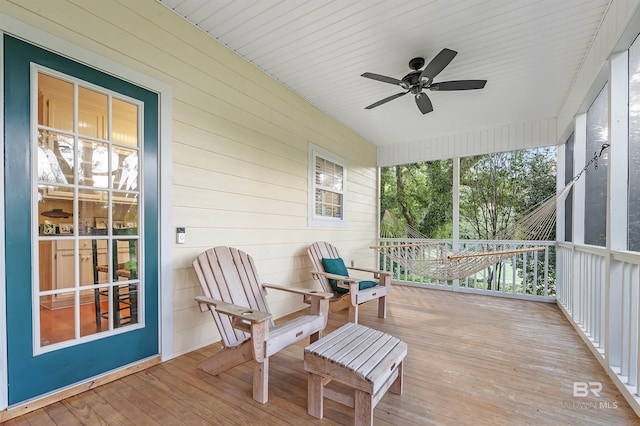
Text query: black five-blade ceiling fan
362 48 487 114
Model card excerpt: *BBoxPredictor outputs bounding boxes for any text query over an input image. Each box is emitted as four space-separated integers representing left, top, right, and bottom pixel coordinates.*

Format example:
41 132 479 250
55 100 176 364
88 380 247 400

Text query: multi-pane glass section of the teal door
34 71 141 348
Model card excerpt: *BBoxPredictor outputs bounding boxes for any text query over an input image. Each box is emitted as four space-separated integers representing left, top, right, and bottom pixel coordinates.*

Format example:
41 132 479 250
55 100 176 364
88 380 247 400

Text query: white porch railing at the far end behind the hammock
378 238 556 302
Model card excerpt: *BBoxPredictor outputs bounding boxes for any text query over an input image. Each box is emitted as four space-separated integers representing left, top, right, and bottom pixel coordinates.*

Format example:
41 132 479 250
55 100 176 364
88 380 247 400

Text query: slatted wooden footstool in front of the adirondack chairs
304 323 407 425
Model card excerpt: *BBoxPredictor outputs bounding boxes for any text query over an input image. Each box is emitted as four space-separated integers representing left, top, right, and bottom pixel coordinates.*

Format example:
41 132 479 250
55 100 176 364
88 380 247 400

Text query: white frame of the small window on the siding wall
307 143 347 227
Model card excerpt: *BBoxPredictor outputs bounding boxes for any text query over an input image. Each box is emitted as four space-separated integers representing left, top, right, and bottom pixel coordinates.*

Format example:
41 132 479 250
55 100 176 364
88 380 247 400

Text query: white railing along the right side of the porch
557 243 640 415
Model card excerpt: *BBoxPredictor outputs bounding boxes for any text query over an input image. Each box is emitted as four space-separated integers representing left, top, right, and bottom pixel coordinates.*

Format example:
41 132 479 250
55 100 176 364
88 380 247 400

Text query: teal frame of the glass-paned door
3 36 160 404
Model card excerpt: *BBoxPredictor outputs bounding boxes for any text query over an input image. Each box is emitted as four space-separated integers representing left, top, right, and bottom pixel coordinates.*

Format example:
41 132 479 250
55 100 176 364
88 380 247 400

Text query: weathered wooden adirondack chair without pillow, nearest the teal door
193 247 331 404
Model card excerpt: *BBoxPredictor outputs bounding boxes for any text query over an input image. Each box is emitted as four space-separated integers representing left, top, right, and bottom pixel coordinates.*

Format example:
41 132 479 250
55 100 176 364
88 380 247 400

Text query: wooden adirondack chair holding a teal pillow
307 241 391 324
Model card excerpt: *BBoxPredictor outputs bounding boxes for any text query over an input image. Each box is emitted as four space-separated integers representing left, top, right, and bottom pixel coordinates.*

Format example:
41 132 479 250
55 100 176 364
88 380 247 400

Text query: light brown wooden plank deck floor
7 286 640 426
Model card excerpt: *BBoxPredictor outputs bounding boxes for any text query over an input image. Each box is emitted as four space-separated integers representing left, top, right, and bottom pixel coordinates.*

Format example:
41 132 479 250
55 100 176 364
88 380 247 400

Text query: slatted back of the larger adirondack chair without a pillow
193 246 276 347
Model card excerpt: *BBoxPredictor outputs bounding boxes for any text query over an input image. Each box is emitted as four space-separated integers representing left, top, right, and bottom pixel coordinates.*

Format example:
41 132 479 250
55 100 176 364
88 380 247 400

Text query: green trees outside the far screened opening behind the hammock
381 148 556 291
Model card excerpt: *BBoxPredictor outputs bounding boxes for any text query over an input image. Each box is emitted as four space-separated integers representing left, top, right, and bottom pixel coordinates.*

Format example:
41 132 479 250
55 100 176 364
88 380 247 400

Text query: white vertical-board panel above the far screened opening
378 118 557 167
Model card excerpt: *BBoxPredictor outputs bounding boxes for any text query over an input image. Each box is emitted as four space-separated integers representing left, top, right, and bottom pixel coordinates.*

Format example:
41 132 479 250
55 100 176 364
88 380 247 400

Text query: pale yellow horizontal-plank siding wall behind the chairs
0 0 378 355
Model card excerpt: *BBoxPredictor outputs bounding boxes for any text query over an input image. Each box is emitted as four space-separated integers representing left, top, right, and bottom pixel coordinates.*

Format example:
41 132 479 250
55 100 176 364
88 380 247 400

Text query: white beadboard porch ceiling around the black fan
158 0 611 146
